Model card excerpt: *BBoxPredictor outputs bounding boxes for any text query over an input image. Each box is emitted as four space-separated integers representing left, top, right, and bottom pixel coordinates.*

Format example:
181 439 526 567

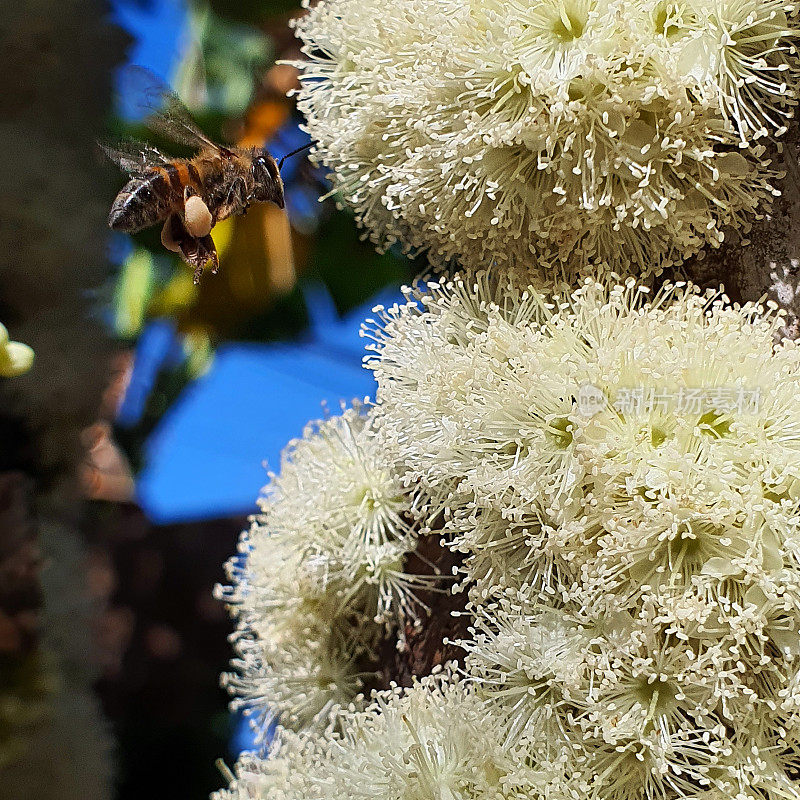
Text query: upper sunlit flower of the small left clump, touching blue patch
250 410 424 620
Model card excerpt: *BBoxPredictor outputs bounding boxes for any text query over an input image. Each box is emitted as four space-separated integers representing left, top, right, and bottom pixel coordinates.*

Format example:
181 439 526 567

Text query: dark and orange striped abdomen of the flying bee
108 162 200 233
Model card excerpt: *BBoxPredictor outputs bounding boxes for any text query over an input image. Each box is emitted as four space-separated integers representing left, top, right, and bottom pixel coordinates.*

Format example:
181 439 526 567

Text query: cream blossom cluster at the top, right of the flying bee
297 0 799 277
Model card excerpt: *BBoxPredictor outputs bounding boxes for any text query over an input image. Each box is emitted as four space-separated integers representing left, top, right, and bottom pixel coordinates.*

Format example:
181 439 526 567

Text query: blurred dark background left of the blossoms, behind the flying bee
0 0 412 800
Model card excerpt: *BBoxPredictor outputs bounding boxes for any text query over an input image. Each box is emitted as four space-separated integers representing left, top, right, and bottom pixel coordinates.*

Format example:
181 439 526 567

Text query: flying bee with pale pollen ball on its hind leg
101 68 306 283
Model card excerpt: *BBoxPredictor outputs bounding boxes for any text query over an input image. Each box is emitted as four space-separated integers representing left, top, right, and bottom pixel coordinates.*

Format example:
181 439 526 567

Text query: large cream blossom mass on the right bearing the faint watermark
360 273 800 800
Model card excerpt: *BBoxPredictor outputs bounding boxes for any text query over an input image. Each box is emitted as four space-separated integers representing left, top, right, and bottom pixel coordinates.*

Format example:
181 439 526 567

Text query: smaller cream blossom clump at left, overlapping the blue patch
219 409 432 730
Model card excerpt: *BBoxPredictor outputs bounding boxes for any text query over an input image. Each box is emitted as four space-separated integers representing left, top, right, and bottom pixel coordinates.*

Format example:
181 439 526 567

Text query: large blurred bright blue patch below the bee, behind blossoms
133 287 403 524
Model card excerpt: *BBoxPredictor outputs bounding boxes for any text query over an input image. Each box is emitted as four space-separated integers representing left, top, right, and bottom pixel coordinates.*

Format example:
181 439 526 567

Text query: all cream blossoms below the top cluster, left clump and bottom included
220 272 800 800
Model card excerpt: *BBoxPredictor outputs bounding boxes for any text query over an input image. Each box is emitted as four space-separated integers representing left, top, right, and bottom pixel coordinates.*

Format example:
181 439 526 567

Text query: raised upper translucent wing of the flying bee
121 66 230 154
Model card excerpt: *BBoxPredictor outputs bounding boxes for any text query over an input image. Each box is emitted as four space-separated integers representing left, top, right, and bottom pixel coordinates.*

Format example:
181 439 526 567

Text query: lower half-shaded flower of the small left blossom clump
217 538 370 735
